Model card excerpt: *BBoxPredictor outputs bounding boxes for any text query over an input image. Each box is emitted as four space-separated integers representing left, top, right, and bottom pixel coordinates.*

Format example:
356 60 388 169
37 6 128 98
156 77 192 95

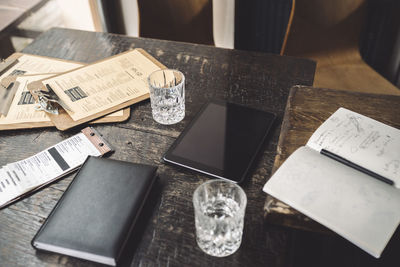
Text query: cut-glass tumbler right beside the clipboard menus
148 69 185 124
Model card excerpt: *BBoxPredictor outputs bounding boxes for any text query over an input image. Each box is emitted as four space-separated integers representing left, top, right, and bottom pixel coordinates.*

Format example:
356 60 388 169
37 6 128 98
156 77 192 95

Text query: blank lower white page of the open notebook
263 147 400 258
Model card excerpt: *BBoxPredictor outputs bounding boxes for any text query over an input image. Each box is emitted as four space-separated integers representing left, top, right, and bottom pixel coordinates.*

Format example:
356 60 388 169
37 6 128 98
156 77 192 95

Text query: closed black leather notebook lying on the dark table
32 157 157 266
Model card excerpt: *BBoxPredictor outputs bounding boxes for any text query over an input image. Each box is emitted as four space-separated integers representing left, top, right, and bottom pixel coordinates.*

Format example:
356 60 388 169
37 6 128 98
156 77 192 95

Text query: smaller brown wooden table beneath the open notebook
264 86 400 232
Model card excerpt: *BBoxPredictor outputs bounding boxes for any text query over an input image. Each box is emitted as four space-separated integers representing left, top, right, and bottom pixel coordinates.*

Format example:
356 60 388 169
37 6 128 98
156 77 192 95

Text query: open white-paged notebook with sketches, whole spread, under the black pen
264 108 400 257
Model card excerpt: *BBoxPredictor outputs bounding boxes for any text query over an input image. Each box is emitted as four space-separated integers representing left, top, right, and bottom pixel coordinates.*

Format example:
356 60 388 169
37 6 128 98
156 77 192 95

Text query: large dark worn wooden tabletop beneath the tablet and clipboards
0 29 392 266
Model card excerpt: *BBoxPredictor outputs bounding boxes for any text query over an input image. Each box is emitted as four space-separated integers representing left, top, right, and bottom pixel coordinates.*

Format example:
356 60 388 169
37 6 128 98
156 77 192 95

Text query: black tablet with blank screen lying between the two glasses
163 101 275 183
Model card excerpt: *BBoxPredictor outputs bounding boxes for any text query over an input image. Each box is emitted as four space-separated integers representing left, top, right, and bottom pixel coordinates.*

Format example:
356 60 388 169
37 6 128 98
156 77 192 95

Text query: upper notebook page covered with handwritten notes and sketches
307 108 400 188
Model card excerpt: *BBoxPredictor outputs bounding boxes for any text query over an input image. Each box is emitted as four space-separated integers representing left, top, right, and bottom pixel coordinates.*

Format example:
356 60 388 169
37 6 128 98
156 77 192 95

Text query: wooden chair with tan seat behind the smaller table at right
283 0 400 95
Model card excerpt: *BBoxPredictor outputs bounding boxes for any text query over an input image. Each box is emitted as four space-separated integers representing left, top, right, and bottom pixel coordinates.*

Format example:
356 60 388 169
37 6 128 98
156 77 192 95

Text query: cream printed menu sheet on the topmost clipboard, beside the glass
42 50 160 121
